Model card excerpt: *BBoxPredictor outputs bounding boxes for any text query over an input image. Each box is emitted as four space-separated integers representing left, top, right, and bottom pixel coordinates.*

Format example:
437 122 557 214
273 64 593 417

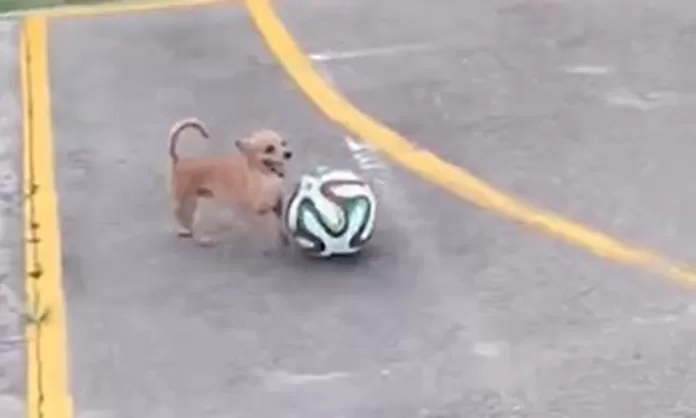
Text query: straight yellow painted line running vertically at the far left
19 17 73 418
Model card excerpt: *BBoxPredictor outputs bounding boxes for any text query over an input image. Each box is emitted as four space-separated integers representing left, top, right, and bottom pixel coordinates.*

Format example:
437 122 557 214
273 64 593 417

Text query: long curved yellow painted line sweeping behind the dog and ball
245 0 696 287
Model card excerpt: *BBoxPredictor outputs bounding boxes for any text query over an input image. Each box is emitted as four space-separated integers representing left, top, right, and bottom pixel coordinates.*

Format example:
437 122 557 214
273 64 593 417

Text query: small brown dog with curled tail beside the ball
169 118 292 245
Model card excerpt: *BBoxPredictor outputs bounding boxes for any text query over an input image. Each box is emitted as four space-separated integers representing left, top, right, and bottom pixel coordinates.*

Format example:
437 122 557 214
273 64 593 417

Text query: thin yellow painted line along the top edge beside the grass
5 0 227 18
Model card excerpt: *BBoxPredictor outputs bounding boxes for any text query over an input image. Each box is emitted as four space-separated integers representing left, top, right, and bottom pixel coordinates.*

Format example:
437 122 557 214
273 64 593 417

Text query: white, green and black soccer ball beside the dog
284 167 377 257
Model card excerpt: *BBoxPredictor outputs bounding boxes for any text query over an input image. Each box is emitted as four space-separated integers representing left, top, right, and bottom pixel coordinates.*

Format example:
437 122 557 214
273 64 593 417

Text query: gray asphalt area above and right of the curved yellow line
281 0 696 261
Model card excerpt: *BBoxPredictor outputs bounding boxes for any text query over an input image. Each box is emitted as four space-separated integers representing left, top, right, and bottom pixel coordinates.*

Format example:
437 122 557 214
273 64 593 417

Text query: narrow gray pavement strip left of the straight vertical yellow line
0 21 26 418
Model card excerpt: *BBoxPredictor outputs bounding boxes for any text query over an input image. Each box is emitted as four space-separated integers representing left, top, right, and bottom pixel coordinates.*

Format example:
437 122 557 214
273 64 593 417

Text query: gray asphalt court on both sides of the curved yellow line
50 0 696 418
